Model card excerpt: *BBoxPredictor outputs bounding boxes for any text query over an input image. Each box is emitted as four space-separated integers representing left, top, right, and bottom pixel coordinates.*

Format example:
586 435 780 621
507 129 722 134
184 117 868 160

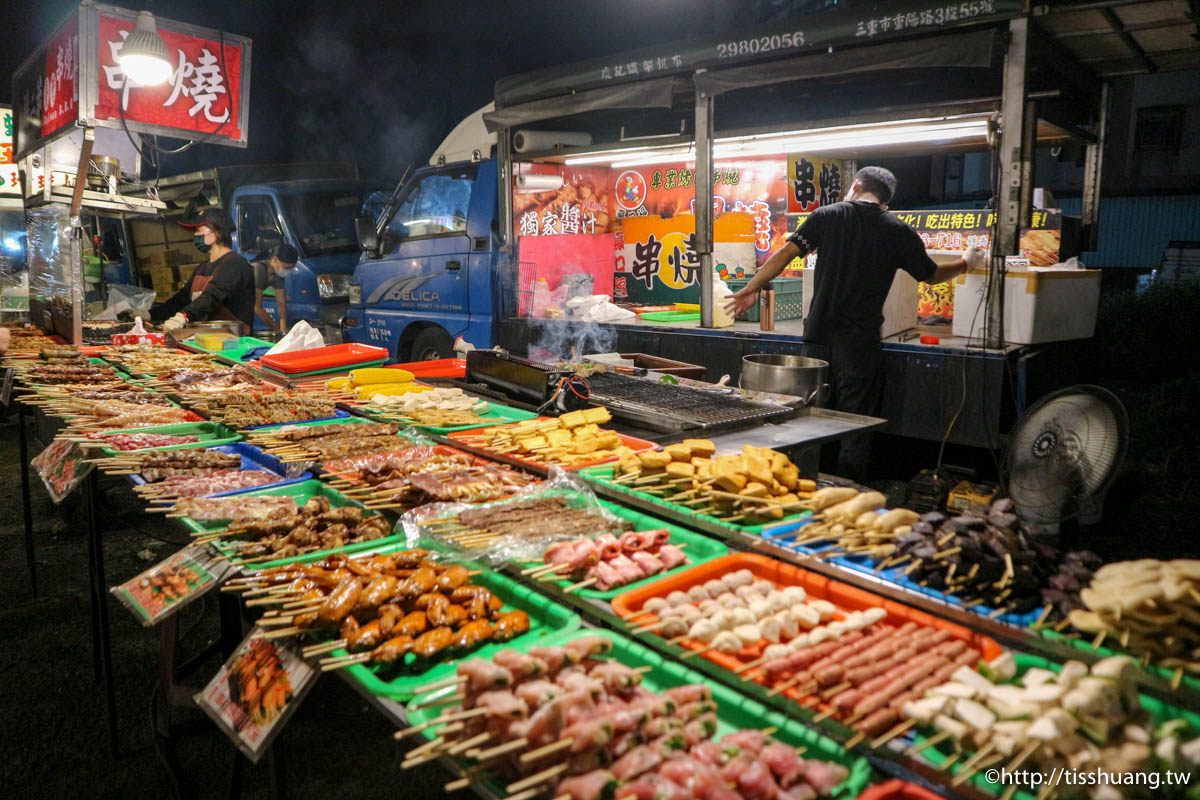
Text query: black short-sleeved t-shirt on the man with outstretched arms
788 200 937 347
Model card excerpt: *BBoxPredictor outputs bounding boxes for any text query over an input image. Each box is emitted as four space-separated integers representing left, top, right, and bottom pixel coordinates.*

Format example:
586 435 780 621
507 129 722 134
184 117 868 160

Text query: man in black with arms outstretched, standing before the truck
727 167 984 480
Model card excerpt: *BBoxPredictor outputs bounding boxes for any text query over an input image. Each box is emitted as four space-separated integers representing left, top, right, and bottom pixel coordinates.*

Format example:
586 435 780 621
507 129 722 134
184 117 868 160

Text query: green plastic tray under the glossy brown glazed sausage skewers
330 570 583 700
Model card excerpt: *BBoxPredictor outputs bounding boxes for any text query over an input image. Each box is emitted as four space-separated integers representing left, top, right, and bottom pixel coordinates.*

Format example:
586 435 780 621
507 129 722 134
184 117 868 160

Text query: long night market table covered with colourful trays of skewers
4 1 1200 800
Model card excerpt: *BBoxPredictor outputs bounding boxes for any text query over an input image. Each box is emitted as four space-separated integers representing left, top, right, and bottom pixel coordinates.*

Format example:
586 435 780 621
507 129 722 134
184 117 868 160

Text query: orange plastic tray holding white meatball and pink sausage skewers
612 553 1004 710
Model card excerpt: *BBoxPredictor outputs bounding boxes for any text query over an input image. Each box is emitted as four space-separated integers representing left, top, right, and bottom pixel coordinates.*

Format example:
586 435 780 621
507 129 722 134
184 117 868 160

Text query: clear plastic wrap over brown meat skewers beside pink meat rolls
400 467 624 565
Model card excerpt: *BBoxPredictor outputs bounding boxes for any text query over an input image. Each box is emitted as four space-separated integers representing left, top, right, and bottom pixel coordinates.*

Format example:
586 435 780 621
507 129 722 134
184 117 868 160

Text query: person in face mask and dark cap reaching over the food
150 209 254 335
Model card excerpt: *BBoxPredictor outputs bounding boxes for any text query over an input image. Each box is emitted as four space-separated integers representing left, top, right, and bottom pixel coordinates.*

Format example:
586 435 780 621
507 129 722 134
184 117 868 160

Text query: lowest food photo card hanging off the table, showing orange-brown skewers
196 627 317 763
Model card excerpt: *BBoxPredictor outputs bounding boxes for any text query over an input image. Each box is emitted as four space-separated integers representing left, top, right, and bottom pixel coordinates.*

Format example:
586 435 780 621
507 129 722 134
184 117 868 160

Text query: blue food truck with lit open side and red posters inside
344 0 1106 446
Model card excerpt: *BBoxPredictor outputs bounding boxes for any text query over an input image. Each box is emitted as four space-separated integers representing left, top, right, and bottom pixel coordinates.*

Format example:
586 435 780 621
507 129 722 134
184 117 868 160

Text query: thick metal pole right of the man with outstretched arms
984 17 1030 348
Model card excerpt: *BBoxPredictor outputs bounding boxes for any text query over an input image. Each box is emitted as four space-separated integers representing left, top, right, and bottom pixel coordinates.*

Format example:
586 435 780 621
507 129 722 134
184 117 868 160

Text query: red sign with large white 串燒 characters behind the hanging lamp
95 14 242 140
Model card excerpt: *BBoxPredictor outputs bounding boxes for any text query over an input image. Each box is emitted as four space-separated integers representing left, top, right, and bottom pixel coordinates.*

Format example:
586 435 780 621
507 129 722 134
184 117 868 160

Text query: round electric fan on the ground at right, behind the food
1004 385 1129 534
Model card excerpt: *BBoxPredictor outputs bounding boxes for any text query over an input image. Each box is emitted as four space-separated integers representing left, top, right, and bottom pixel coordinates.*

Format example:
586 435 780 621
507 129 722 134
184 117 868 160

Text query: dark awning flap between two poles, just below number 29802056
692 30 996 95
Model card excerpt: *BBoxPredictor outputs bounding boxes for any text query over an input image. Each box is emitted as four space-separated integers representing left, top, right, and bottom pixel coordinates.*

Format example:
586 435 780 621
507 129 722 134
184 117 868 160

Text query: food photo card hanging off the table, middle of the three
112 545 234 626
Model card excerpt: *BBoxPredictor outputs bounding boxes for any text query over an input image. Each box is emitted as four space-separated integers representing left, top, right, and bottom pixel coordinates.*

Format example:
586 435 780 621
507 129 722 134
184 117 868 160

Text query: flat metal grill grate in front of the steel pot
588 372 794 431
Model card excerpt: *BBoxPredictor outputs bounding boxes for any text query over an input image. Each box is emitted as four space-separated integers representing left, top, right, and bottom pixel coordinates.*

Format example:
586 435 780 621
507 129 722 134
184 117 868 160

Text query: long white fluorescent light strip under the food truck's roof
565 116 988 168
